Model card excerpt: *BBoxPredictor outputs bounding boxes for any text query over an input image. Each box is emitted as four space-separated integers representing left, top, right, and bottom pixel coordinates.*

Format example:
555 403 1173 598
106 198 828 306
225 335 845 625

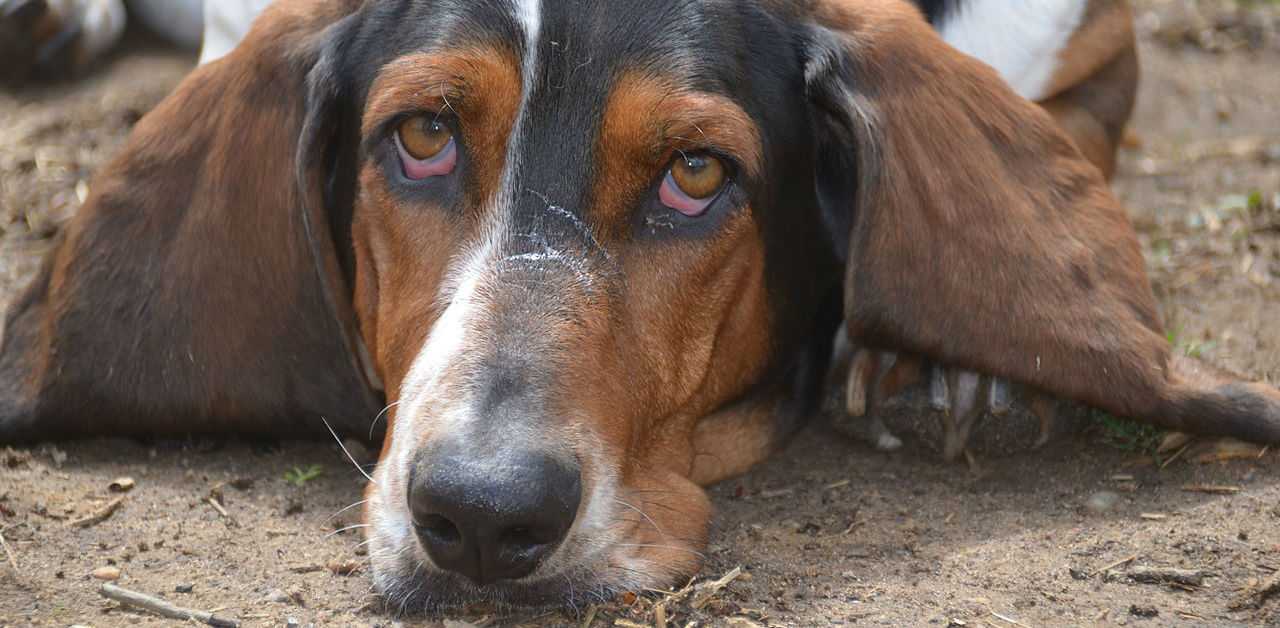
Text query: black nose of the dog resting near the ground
408 448 581 585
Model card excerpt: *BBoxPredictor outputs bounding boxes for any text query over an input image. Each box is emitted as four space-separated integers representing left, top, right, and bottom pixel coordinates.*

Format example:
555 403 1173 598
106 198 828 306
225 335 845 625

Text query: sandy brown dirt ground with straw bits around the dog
0 0 1280 628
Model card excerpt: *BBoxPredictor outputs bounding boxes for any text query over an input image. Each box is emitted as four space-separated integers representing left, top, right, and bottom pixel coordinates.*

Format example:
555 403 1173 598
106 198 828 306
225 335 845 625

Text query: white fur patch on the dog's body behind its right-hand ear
938 0 1089 100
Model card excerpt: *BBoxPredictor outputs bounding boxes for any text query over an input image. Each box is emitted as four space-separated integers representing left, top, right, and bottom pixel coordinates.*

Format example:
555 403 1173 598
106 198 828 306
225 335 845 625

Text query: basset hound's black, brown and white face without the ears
346 0 838 605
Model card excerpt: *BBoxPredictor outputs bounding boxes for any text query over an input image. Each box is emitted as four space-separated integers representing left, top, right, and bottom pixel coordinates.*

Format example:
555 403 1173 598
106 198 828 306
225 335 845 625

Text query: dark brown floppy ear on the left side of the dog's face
0 0 379 441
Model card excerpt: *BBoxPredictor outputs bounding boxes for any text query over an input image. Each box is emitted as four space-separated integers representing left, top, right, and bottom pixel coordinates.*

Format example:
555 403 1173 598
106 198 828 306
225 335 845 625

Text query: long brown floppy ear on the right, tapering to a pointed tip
806 0 1280 443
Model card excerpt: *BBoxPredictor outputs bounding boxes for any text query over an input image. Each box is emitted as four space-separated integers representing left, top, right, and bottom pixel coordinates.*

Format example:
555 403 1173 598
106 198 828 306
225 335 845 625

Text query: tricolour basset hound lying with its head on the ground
0 0 1280 609
